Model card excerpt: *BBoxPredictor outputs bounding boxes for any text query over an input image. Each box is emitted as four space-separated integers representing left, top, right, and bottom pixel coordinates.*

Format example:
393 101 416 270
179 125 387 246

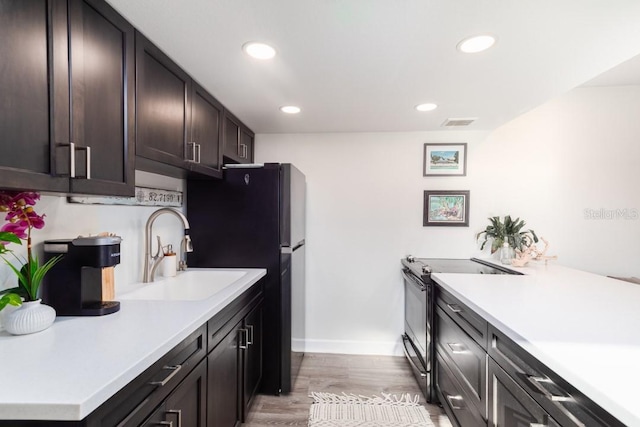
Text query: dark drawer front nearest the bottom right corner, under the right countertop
488 326 624 427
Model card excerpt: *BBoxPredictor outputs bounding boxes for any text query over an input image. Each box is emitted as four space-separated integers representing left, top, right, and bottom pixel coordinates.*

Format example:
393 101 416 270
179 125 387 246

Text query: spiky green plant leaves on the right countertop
476 215 538 253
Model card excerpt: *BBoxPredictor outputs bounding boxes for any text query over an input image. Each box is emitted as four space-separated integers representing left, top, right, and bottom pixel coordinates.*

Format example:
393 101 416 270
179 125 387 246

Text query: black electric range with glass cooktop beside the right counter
401 256 521 402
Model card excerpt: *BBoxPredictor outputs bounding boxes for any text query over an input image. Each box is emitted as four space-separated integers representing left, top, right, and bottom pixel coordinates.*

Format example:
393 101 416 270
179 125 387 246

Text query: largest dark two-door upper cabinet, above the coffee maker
0 0 135 195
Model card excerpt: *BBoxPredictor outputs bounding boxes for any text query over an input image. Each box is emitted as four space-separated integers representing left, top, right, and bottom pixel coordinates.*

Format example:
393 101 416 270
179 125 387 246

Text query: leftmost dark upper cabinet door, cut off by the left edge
0 0 69 191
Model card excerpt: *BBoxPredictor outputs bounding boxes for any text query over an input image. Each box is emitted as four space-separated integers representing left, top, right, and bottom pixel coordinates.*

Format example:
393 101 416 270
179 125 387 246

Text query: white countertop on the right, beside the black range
432 262 640 426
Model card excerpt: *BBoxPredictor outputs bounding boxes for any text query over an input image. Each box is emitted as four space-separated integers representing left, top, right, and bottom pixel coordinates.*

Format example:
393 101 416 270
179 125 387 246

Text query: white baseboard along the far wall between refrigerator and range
291 338 403 356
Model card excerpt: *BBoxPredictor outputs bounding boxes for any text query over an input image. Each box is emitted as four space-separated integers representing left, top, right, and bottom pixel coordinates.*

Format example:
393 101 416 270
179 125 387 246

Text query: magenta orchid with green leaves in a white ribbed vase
0 191 61 334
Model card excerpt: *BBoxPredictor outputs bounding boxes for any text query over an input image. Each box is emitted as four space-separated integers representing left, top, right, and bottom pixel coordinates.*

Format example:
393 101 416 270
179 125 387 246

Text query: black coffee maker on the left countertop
42 236 122 316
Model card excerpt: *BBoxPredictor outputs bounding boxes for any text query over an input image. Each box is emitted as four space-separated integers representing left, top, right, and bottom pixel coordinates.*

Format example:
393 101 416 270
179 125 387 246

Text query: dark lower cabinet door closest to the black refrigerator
242 302 262 422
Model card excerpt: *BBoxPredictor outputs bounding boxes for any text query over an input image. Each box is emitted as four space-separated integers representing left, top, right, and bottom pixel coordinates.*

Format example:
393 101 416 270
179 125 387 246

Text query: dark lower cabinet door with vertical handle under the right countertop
489 360 559 427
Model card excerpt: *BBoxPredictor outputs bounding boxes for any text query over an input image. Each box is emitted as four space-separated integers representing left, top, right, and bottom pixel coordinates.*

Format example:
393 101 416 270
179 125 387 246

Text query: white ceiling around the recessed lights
107 0 640 133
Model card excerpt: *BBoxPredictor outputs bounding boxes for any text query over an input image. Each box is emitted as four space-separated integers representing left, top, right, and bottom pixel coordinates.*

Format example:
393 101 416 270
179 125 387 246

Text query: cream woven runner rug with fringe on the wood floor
309 392 434 427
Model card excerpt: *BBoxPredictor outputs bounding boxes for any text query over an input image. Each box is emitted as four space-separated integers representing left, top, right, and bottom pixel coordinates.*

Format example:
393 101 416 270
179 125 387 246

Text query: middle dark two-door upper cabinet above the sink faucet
136 32 223 177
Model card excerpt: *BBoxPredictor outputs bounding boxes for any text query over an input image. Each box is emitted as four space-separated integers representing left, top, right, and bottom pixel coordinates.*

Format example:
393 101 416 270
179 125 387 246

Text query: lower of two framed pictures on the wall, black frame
422 190 469 227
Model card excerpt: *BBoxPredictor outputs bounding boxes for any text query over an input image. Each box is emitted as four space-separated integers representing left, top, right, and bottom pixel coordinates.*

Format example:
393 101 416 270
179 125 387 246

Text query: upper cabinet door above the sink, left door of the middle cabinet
136 32 191 168
